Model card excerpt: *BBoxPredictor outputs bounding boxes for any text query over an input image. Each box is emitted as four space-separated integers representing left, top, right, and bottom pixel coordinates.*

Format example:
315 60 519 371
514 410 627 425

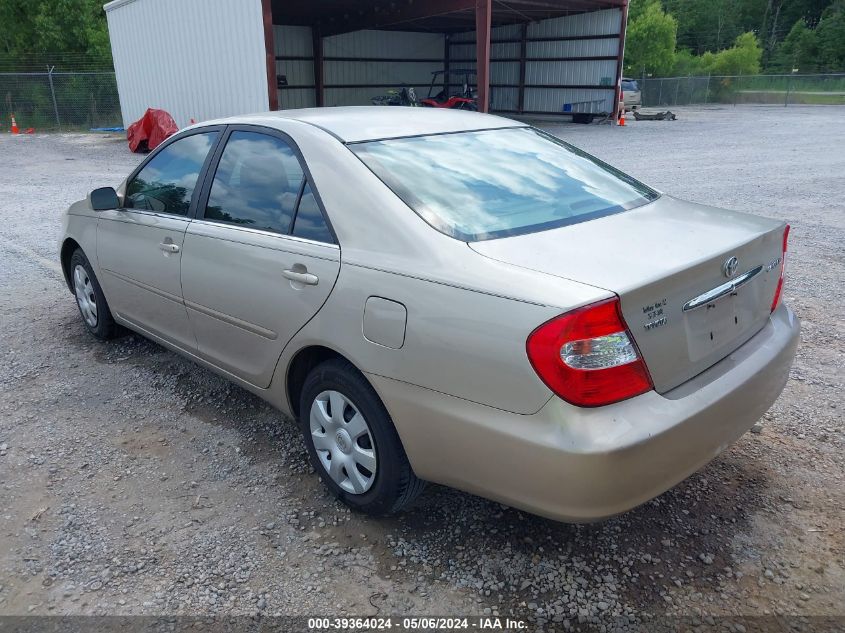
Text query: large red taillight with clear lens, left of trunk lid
526 297 654 407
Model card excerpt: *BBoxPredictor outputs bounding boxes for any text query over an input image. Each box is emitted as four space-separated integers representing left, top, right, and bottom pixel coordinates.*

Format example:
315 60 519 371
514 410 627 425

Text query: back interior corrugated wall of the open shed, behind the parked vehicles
273 25 445 108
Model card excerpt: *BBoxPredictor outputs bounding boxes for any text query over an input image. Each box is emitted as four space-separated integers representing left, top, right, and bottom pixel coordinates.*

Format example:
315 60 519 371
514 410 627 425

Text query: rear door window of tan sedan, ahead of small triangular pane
205 131 304 233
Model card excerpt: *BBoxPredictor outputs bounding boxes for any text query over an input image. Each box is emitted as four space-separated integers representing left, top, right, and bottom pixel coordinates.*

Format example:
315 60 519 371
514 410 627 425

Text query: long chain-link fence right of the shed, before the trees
638 73 845 108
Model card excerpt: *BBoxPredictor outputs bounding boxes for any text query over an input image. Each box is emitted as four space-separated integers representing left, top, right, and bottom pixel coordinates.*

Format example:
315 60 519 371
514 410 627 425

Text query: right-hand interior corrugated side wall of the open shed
449 9 622 114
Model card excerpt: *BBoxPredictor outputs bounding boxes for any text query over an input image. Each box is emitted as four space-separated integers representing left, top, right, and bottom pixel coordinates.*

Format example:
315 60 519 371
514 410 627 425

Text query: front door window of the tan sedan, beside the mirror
123 132 217 215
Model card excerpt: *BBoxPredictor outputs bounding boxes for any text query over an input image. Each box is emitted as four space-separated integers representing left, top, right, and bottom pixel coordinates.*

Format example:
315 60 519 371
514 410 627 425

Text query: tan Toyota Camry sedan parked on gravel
60 107 799 521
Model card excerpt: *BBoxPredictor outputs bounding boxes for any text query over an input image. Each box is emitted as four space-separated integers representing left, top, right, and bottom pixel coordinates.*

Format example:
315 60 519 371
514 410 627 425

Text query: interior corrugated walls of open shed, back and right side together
275 9 622 114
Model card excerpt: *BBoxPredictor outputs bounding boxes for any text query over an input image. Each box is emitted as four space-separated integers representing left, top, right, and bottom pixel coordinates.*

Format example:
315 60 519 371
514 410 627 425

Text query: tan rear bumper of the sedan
369 305 799 522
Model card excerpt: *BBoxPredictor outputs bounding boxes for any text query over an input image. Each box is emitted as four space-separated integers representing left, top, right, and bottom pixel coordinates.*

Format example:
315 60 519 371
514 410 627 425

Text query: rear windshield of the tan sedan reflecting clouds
349 128 658 242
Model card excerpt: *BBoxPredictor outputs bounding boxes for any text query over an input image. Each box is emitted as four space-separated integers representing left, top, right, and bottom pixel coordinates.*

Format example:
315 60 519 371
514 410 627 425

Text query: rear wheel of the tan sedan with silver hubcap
299 359 424 516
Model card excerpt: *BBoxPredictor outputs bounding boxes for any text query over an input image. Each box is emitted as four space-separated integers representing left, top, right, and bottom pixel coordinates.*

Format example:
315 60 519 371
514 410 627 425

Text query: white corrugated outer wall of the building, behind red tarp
105 0 269 126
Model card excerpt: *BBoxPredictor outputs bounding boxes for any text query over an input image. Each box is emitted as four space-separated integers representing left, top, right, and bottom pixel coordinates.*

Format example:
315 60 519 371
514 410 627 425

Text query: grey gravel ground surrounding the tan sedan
0 106 845 631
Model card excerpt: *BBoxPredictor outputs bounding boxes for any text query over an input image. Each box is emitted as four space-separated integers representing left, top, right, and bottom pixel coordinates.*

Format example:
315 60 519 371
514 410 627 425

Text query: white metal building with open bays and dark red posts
105 0 627 126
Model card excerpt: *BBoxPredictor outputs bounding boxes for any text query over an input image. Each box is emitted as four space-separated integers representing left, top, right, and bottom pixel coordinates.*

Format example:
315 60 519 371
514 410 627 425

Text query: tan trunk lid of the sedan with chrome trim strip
469 196 784 393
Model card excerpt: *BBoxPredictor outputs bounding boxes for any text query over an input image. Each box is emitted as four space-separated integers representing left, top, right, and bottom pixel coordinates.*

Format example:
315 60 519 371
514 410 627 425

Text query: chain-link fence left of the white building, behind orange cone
0 68 123 132
